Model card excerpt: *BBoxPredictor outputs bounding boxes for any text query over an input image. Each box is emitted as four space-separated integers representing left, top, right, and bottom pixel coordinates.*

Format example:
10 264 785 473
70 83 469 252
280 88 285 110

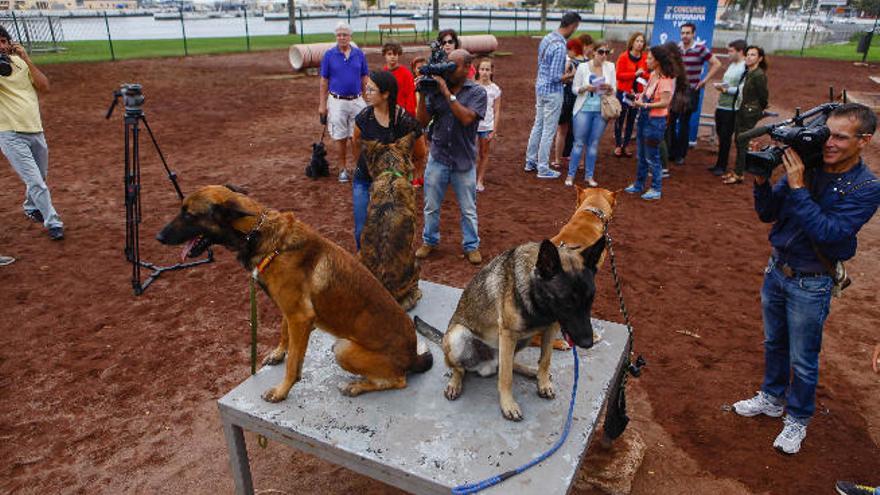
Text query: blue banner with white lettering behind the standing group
651 0 718 144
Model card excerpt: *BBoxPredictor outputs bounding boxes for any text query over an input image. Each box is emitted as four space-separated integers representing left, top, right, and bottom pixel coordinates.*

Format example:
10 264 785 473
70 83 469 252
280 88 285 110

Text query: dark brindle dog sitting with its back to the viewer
359 134 422 311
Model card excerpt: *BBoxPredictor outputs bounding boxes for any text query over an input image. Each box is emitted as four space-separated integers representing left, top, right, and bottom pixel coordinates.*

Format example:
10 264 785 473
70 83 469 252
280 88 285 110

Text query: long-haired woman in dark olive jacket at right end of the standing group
721 45 770 184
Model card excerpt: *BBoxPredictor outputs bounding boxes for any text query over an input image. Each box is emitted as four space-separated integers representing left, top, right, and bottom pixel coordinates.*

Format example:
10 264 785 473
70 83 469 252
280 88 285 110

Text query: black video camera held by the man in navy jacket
737 102 840 177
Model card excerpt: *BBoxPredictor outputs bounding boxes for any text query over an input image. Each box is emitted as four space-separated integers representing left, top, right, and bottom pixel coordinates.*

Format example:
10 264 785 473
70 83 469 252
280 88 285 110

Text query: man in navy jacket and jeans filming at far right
733 103 880 454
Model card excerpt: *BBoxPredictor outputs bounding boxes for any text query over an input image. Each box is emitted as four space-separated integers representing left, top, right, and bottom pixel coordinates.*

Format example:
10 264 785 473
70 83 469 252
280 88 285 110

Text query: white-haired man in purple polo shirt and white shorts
318 22 370 182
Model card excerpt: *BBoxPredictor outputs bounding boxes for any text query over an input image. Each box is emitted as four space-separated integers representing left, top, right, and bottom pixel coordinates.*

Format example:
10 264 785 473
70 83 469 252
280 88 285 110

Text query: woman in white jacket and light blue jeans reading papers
565 41 620 187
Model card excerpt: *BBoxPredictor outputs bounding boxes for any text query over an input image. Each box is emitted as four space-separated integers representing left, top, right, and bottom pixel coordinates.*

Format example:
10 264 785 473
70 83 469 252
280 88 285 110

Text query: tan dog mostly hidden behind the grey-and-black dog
530 185 617 351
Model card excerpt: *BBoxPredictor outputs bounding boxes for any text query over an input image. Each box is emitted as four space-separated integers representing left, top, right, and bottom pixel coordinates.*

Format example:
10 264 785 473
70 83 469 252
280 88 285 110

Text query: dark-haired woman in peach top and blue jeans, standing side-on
624 45 680 200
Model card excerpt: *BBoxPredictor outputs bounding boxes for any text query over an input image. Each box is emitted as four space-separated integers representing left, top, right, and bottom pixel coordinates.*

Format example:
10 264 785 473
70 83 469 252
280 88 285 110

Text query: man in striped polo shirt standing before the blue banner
668 22 721 165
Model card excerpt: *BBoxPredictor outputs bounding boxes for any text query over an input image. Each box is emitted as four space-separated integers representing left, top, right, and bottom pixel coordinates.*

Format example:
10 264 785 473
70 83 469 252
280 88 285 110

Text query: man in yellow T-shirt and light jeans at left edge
0 26 64 241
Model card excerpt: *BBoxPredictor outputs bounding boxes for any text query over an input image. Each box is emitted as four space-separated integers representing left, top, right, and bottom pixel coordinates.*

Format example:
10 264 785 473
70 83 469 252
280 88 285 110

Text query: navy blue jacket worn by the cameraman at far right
754 161 880 272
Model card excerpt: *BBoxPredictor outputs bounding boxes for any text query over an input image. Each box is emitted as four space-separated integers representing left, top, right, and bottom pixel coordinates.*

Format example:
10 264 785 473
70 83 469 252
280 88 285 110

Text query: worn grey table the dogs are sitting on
218 281 627 495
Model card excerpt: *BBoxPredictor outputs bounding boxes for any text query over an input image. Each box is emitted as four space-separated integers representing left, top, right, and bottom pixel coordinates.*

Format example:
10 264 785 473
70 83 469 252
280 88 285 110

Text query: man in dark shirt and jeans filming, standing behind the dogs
416 49 486 265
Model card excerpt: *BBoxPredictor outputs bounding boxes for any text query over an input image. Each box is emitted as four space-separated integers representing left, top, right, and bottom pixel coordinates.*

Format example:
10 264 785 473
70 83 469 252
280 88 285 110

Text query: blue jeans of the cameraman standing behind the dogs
422 155 480 253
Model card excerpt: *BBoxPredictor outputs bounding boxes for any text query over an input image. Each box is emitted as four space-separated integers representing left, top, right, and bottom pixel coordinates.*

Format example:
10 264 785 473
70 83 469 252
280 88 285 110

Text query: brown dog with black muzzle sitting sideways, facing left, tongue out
156 186 433 402
